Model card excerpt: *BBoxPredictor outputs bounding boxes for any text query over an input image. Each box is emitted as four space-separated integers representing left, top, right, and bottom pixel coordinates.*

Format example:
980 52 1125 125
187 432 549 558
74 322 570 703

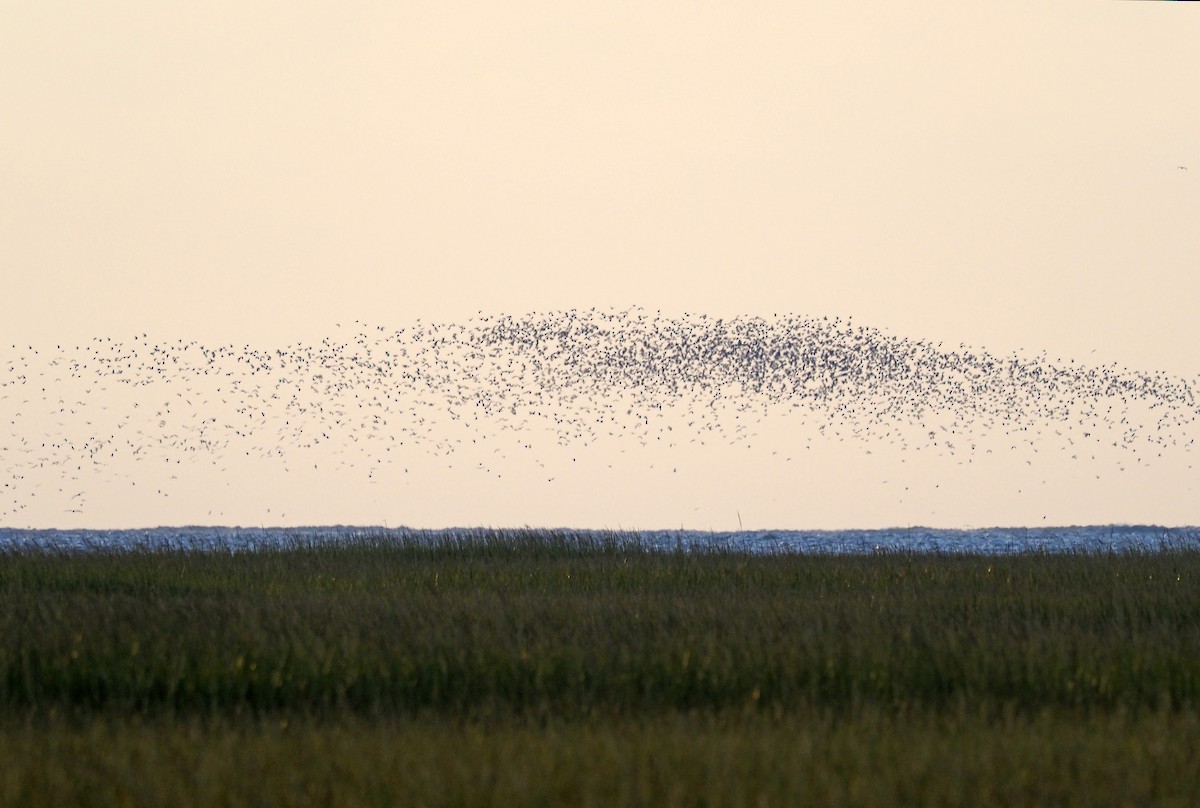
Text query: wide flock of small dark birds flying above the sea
0 309 1200 523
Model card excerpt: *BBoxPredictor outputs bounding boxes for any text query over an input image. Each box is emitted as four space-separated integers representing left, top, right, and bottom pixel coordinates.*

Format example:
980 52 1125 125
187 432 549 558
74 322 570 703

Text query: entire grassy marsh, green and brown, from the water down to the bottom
0 533 1200 806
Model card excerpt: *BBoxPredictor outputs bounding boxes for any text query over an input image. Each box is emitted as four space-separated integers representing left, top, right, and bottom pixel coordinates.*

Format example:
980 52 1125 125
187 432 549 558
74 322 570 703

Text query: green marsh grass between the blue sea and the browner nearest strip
0 537 1200 716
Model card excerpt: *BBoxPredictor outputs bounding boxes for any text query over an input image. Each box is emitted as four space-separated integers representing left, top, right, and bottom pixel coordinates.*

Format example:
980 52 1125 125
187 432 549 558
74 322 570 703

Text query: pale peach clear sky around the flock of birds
0 0 1200 527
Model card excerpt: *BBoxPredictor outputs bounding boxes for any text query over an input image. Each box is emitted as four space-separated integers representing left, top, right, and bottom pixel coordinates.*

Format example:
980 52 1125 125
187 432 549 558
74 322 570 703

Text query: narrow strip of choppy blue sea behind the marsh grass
0 525 1200 555
